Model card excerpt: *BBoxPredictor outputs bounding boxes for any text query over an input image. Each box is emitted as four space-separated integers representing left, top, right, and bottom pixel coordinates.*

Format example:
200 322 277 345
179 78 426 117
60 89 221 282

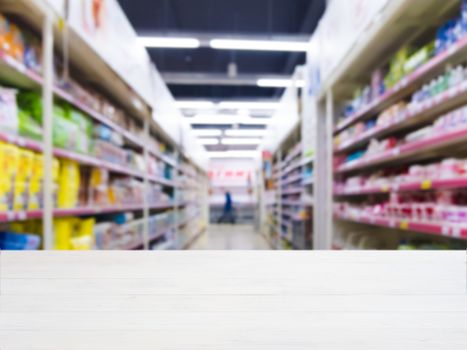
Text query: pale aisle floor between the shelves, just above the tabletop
191 225 270 250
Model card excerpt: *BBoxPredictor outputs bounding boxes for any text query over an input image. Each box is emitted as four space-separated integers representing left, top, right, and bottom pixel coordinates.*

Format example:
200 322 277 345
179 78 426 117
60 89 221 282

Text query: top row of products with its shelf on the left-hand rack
0 9 188 171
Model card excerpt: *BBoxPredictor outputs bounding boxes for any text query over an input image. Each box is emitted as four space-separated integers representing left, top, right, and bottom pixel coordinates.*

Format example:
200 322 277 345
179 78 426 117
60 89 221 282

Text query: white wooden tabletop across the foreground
0 251 467 350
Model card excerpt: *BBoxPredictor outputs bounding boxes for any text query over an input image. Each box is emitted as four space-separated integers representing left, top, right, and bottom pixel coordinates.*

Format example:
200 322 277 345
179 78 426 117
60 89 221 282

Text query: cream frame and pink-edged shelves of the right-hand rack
306 0 467 249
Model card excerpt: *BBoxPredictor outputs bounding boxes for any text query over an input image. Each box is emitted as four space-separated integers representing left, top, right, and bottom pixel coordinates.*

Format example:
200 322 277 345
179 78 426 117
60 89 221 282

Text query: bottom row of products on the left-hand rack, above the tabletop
0 209 202 250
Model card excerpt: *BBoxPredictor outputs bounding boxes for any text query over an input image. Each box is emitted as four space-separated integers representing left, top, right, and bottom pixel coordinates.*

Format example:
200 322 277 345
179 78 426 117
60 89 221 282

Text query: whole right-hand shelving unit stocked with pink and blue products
306 0 467 249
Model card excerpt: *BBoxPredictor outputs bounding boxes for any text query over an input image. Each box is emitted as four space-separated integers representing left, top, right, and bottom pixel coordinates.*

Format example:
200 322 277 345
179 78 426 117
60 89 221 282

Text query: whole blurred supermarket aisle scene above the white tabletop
0 0 467 250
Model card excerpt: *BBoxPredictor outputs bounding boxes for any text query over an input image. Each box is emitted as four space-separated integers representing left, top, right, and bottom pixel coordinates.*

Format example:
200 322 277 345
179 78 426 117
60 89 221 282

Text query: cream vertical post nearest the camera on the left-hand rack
42 9 54 250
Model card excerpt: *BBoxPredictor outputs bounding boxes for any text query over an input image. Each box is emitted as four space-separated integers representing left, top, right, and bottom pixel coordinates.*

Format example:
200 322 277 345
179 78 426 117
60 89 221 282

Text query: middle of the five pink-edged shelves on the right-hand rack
337 127 467 173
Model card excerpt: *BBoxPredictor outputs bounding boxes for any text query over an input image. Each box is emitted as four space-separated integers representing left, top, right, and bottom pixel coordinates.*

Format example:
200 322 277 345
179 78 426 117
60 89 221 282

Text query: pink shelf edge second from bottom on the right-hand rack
334 177 467 196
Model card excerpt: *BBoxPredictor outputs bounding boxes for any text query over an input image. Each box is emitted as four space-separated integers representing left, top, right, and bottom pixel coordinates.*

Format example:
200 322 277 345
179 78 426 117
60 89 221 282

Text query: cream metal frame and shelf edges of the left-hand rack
0 0 207 249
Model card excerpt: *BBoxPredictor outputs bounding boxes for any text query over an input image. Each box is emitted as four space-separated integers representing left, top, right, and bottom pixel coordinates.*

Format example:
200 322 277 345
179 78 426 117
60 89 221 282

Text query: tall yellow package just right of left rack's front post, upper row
57 160 80 208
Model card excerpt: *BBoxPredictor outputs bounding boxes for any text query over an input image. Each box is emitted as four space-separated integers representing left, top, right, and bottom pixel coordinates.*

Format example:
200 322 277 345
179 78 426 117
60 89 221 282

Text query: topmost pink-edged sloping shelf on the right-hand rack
334 36 467 134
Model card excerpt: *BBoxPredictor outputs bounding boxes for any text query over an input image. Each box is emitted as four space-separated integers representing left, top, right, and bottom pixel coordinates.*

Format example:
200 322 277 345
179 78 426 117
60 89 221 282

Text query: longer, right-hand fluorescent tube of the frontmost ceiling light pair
209 39 310 52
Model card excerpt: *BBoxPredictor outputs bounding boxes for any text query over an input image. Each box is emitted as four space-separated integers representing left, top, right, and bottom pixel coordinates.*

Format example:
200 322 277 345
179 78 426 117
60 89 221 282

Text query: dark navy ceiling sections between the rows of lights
119 0 326 98
